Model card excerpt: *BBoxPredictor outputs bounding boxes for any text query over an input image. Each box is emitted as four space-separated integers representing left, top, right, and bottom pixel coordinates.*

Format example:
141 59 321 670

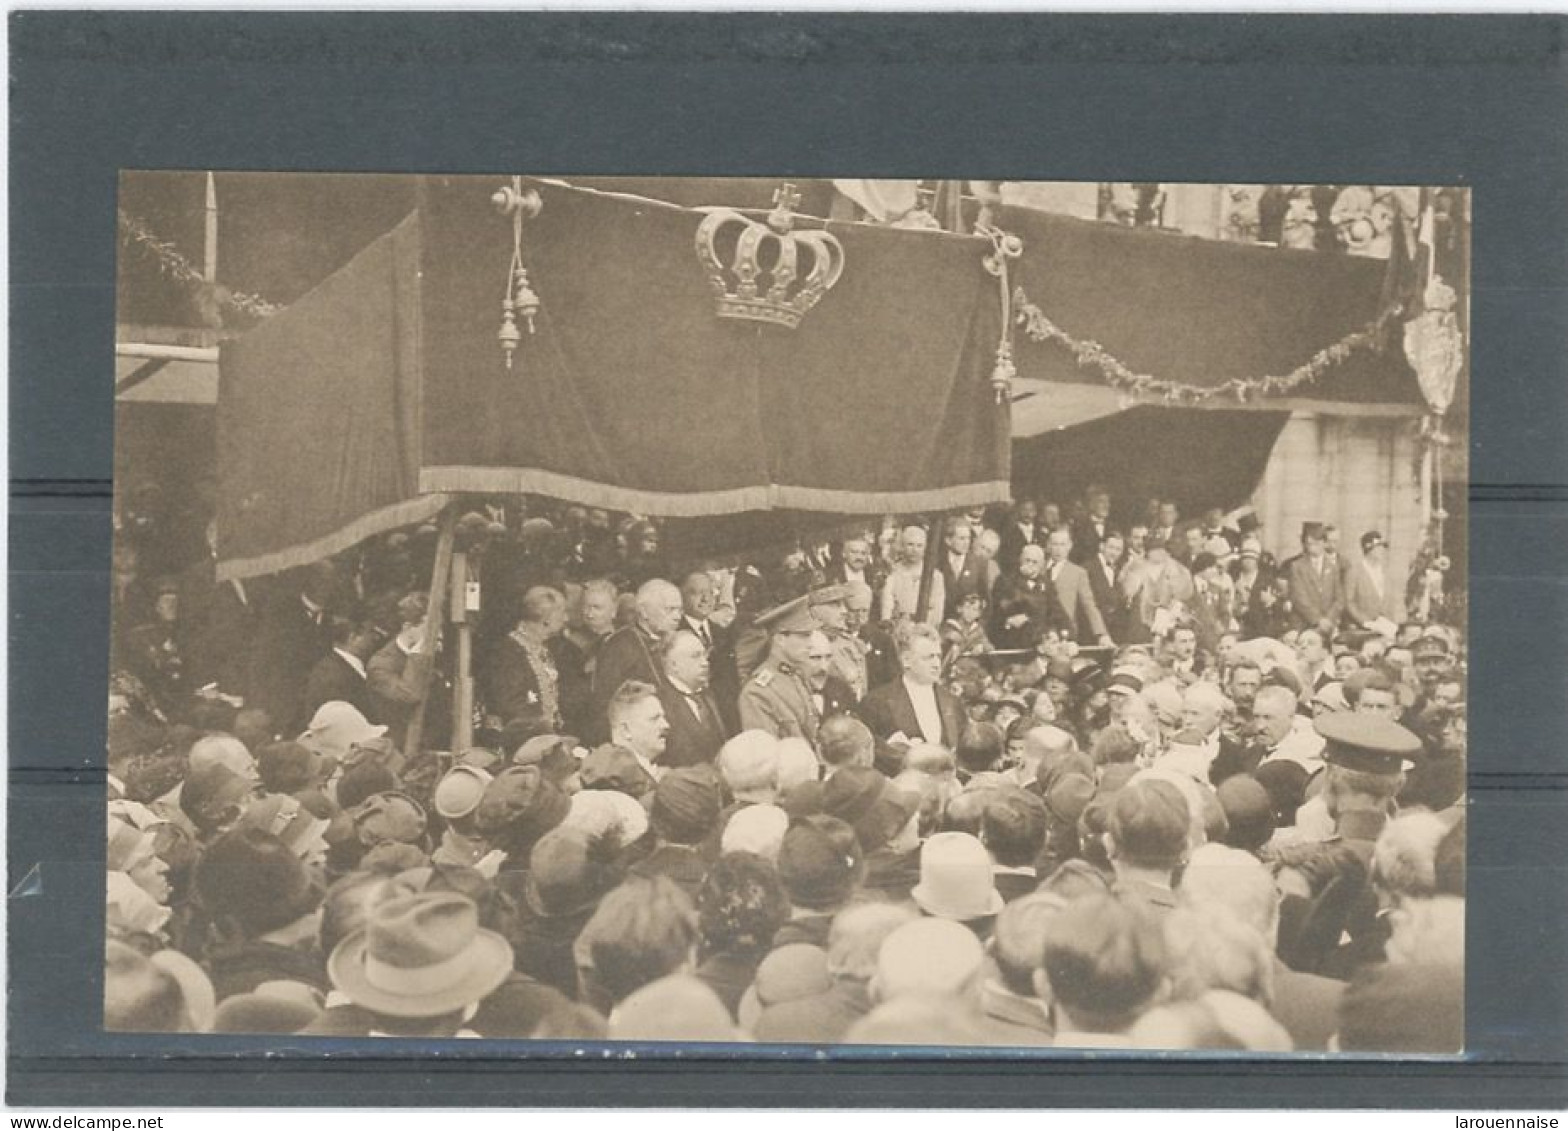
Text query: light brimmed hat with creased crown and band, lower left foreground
326 891 513 1016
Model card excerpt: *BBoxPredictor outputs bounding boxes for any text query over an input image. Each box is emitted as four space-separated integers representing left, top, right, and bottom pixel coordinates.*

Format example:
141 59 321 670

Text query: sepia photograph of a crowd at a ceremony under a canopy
104 174 1471 1057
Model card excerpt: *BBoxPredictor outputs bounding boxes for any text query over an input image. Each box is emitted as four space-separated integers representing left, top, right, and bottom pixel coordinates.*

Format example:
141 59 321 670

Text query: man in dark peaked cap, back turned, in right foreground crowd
1279 712 1422 977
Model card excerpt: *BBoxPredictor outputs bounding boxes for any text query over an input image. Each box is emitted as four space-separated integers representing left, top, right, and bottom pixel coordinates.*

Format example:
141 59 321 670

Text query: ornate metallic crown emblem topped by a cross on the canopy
696 184 844 329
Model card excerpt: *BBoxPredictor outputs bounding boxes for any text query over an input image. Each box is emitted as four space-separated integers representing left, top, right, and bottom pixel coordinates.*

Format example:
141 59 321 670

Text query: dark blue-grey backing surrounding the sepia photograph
8 13 1568 1109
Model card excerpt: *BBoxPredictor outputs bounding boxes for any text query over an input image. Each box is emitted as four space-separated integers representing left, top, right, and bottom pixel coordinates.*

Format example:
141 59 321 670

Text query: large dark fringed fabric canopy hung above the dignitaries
218 177 1010 577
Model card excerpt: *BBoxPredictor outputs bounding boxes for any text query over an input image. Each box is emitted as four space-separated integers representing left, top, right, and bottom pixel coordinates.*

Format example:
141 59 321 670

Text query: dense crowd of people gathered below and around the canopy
105 488 1466 1053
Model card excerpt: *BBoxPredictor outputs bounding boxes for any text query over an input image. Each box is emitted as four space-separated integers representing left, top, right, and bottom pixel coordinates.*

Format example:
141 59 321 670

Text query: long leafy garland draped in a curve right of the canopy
1013 287 1403 405
